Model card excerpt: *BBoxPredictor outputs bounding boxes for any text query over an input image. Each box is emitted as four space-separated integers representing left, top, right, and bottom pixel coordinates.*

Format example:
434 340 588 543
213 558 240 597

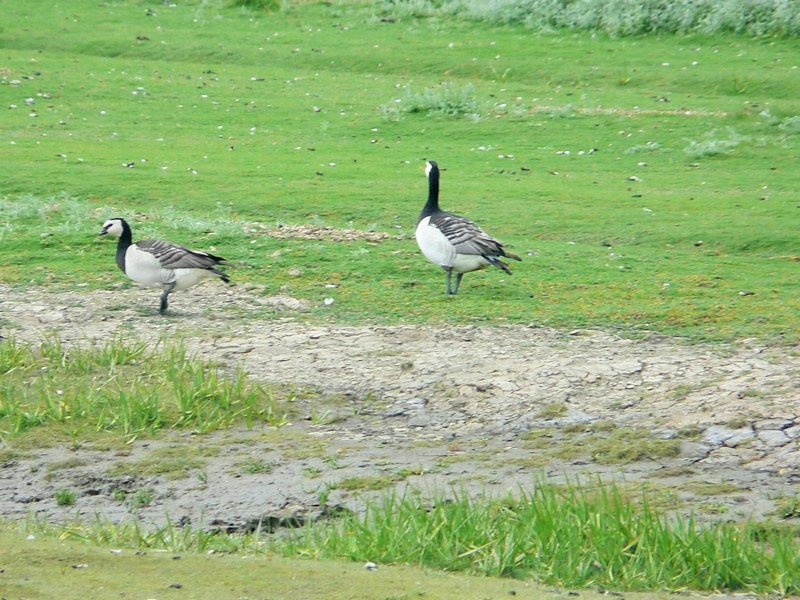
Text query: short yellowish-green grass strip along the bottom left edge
0 524 644 600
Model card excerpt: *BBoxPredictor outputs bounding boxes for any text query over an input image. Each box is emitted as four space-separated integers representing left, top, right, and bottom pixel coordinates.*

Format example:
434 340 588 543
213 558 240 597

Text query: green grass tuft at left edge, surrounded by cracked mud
0 338 283 439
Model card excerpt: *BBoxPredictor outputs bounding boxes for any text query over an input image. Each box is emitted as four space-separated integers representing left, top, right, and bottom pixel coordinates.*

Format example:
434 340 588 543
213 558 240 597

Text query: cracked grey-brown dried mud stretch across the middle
0 284 800 531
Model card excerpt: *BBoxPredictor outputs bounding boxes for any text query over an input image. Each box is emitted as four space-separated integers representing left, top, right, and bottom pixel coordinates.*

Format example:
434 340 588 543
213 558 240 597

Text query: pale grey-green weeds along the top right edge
379 0 800 37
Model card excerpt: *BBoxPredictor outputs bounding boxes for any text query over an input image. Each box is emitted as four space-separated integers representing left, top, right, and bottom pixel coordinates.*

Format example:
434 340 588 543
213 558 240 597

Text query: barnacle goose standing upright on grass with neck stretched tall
416 160 522 295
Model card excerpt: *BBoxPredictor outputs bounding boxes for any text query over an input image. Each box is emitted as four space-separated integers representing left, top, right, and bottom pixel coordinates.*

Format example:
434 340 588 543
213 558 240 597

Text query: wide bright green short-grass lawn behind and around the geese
0 0 800 342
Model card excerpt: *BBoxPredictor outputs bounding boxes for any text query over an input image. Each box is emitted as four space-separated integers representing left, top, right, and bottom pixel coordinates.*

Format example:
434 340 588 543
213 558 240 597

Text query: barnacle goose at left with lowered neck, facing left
100 218 230 315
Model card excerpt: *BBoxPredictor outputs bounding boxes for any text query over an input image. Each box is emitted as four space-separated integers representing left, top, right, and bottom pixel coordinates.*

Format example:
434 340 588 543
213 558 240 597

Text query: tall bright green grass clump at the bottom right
278 485 800 594
